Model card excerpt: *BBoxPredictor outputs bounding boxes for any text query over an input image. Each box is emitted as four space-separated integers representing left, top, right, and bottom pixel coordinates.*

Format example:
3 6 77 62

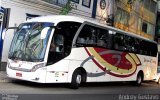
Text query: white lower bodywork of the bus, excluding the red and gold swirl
7 48 157 83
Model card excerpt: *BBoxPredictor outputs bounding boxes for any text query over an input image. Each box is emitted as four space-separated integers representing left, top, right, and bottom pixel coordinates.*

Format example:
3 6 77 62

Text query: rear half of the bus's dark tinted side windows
114 33 157 56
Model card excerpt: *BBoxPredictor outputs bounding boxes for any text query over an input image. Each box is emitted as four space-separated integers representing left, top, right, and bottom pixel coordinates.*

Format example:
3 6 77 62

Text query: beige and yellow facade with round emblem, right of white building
94 0 157 40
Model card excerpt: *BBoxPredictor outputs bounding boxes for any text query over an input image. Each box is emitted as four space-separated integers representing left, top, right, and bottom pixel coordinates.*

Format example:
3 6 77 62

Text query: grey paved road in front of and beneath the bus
0 71 160 100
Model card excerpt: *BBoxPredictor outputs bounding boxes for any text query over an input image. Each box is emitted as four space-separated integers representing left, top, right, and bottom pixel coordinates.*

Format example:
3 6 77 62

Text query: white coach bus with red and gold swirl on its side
7 15 158 88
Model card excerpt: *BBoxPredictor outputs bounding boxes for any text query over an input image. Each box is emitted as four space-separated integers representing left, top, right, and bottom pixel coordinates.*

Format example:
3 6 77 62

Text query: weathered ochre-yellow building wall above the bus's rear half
115 0 157 40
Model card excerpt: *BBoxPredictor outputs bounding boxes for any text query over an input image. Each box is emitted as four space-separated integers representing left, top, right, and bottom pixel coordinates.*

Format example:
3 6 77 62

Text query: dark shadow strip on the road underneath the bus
10 80 158 88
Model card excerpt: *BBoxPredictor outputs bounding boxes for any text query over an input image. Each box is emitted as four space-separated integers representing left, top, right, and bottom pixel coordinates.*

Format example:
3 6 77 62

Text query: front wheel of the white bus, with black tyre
71 70 82 89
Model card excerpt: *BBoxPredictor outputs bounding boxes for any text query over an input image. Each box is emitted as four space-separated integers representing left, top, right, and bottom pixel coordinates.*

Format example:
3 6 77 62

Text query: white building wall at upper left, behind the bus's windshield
1 0 60 62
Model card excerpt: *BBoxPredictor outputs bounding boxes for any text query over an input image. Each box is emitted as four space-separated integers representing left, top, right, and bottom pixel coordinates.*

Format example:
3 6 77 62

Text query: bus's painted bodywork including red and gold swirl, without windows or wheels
7 16 157 83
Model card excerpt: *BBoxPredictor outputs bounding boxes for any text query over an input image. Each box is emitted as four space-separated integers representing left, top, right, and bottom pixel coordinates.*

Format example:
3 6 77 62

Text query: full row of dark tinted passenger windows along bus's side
76 25 157 57
